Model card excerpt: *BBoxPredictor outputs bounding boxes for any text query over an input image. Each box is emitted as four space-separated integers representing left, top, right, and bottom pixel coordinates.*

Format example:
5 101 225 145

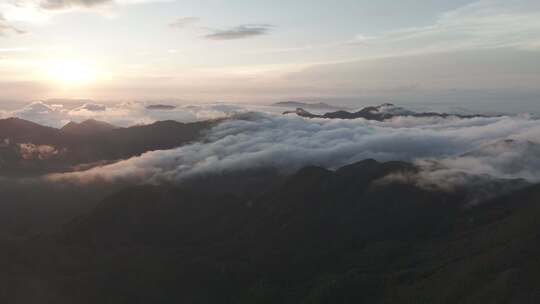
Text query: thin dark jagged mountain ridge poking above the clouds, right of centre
283 103 492 121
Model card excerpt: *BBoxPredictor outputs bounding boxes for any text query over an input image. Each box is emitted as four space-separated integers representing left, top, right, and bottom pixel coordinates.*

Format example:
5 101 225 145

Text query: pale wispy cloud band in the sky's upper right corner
344 0 540 58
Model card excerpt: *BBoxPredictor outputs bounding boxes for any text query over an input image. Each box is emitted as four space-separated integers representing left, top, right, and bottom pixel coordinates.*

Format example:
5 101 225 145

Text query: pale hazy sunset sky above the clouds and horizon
0 0 540 112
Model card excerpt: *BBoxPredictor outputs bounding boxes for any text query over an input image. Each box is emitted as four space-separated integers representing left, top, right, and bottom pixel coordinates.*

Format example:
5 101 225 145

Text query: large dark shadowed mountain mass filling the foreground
0 160 540 303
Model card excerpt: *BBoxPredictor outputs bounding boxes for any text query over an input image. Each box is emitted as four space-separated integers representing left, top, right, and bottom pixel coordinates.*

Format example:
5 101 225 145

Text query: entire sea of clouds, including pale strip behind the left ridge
4 102 540 189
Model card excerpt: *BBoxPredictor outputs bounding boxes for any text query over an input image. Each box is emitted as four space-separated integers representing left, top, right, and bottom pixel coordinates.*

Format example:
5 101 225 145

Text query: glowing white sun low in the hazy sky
47 61 97 85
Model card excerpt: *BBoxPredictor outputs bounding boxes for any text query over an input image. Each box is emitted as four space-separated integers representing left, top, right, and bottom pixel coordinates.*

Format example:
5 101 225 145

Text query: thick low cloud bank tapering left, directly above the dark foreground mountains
45 113 540 184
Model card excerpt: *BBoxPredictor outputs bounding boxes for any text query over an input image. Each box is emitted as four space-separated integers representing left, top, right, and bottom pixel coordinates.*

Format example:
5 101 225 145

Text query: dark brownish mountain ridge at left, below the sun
0 118 216 176
